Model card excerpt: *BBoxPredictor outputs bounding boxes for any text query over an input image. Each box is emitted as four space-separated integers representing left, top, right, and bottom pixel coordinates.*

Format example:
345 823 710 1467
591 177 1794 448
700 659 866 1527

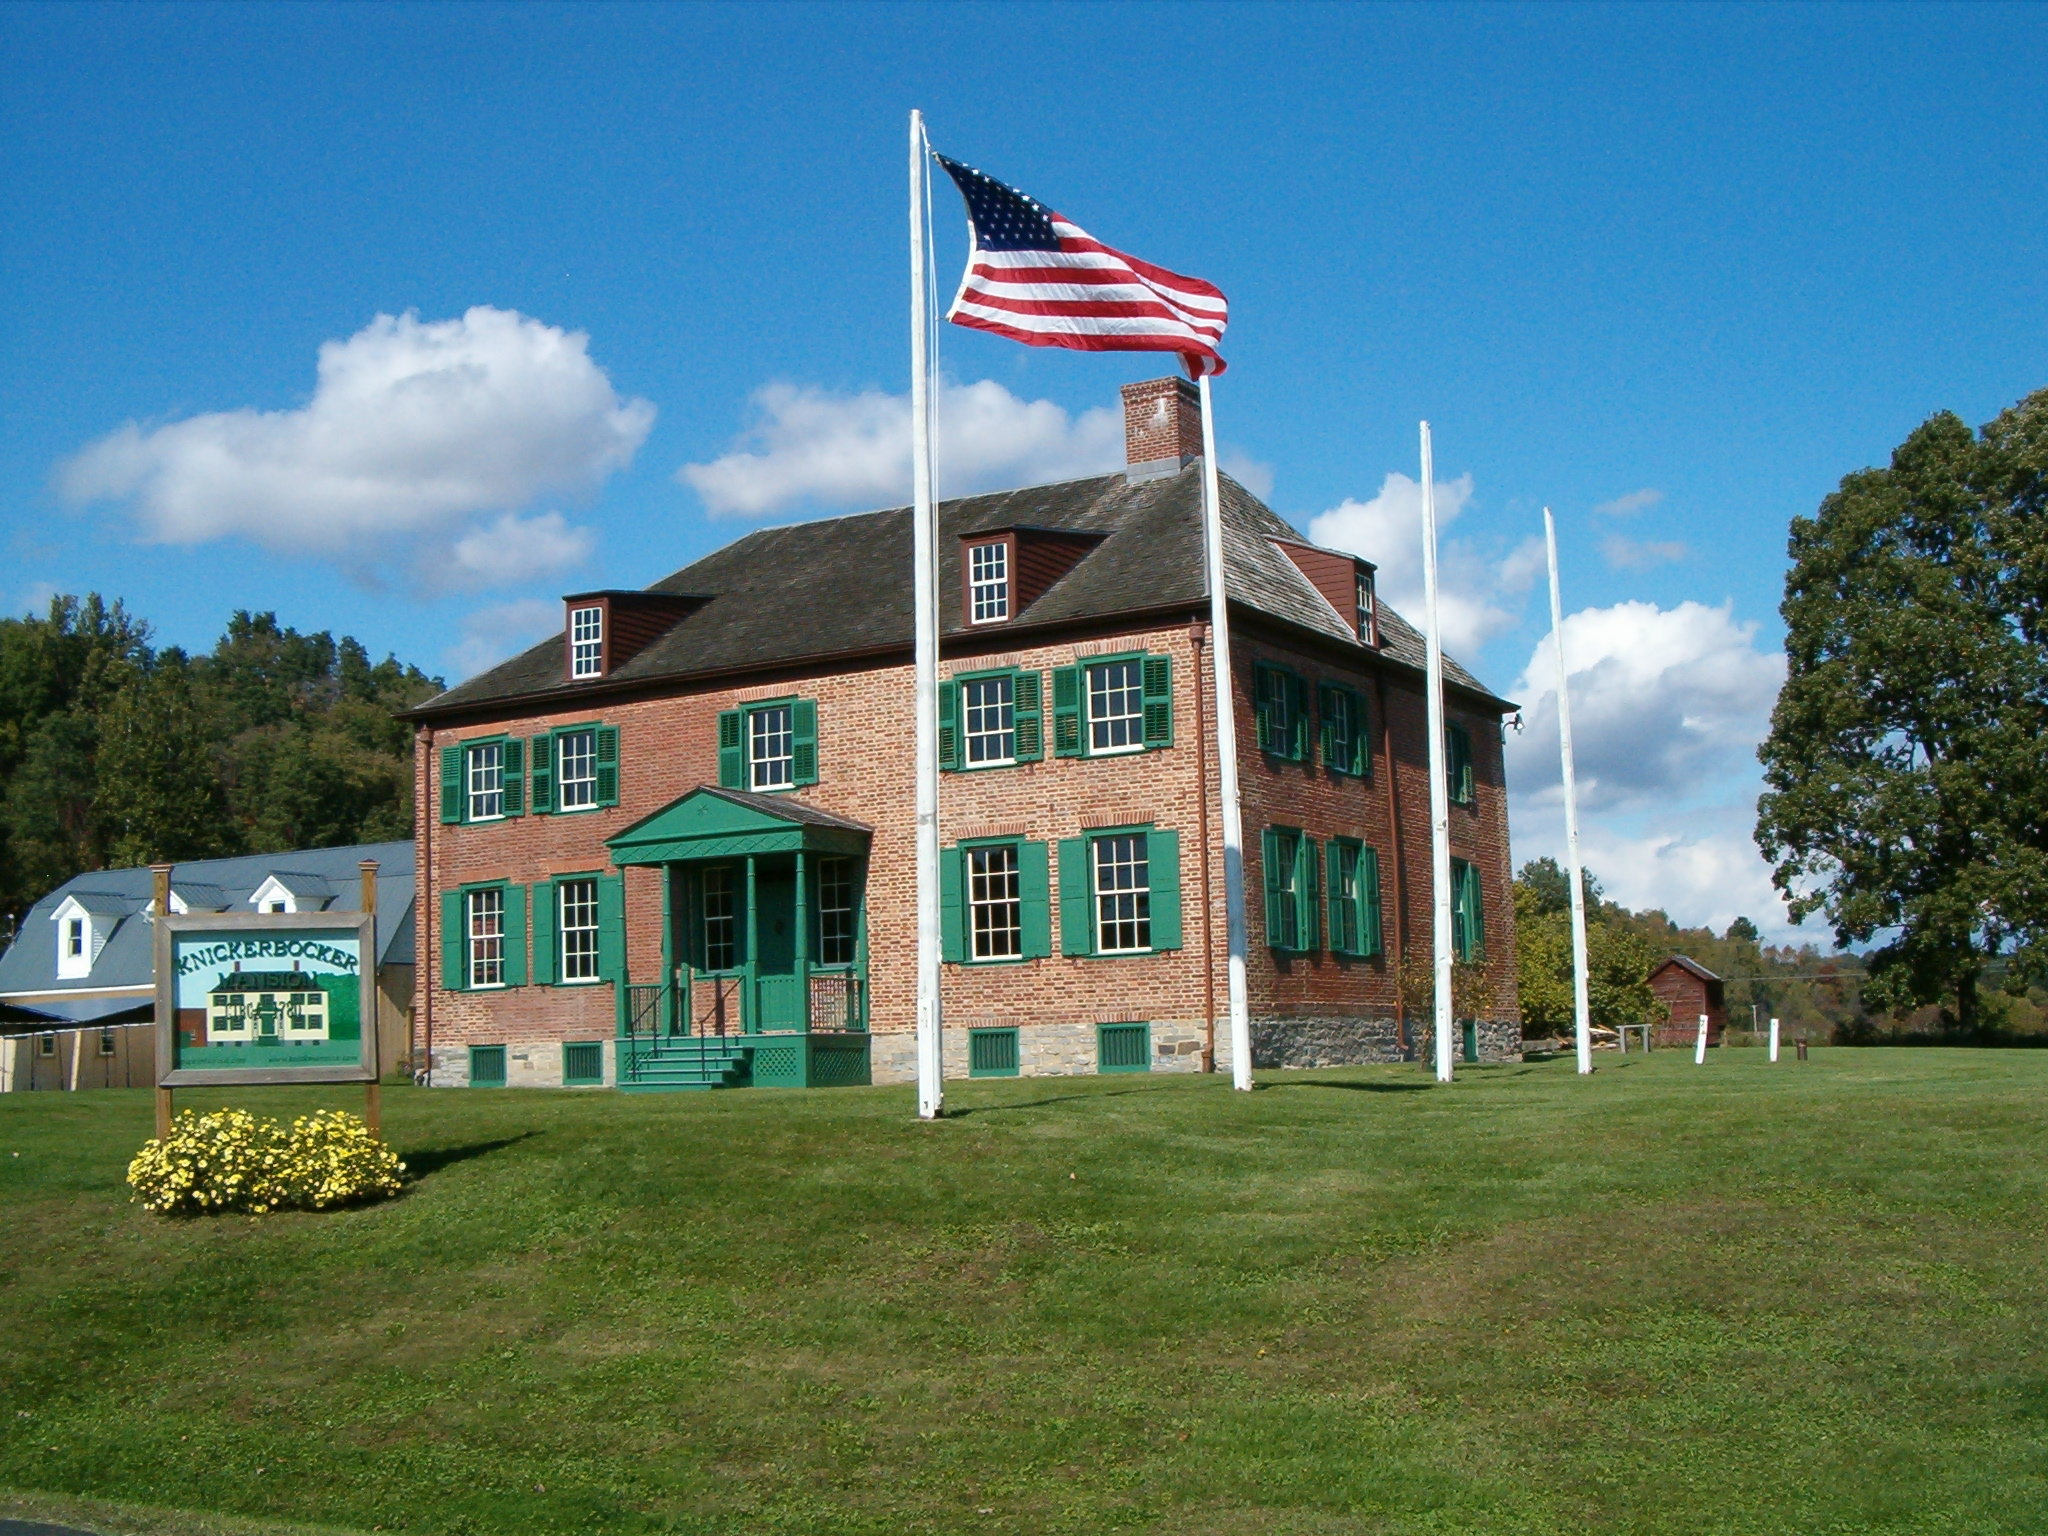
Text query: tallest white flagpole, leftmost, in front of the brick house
909 111 946 1120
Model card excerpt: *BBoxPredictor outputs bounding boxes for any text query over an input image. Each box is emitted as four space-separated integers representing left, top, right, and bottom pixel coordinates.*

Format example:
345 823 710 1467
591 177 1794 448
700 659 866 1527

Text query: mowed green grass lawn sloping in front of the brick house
0 1049 2048 1536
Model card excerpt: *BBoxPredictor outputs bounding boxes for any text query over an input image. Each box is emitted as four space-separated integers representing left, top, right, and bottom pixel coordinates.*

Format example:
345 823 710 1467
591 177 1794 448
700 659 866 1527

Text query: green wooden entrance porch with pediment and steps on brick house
606 784 872 1092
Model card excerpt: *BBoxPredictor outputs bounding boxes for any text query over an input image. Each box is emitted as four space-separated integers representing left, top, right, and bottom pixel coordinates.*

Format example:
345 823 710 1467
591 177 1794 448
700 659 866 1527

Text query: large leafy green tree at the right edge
1757 391 2048 1030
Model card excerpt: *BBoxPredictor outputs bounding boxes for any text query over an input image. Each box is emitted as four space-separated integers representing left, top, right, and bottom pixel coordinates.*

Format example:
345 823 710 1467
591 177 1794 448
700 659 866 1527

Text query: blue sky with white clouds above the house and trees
0 4 2048 946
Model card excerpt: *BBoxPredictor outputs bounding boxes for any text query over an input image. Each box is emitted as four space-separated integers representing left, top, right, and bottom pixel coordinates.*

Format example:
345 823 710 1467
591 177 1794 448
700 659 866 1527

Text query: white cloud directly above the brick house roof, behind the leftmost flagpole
676 379 1124 518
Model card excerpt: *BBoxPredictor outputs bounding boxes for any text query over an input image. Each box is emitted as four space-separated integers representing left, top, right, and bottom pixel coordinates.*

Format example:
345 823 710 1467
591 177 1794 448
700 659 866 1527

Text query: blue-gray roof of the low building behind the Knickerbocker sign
0 842 414 1001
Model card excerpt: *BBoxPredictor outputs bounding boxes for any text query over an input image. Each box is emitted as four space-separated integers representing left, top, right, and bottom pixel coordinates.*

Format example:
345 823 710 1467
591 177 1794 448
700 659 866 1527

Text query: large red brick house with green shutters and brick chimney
410 379 1520 1090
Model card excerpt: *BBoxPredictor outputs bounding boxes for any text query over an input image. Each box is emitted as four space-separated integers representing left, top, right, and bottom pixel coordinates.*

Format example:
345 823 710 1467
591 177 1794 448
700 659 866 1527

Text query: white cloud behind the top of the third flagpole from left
1309 473 1542 655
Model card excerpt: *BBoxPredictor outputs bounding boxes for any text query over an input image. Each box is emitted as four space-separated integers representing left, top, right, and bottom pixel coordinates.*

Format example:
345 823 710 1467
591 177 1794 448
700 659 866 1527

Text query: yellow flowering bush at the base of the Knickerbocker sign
129 1110 406 1217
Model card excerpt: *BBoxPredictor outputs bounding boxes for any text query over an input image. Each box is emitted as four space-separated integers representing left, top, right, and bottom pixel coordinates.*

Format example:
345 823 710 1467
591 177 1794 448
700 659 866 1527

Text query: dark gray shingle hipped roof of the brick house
414 463 1493 715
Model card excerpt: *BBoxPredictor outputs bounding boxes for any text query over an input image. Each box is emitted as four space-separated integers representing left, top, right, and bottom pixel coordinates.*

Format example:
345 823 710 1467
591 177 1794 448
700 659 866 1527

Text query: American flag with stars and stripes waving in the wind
936 156 1231 375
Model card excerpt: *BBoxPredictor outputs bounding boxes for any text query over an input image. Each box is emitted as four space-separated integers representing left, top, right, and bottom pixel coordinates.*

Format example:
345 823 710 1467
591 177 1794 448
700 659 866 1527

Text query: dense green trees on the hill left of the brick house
0 594 444 932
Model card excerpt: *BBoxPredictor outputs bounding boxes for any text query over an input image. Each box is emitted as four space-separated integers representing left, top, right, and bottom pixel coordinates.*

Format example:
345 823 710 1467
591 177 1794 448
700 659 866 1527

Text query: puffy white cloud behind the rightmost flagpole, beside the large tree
1507 602 1786 809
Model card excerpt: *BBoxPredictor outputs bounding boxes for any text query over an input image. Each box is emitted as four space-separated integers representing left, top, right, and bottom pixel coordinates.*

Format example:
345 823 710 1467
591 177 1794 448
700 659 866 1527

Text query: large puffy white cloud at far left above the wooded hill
57 305 653 571
